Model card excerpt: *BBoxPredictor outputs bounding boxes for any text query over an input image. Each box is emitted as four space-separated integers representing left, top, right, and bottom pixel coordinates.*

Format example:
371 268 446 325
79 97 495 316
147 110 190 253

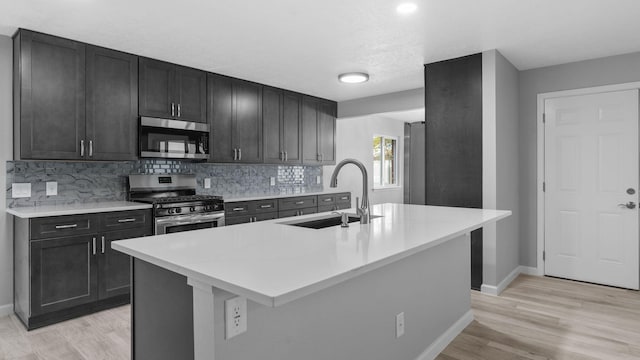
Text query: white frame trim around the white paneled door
536 81 640 276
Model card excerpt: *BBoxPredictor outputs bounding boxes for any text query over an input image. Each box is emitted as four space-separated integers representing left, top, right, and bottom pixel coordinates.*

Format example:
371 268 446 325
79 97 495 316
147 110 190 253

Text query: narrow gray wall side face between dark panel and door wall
495 51 520 281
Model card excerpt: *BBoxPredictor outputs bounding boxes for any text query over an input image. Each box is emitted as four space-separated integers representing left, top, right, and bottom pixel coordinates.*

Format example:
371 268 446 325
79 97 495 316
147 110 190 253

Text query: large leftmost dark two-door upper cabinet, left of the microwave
14 30 138 160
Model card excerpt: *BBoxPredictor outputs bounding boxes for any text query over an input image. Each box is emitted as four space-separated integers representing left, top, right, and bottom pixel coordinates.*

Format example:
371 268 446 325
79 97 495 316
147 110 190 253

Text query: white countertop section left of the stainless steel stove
7 201 152 219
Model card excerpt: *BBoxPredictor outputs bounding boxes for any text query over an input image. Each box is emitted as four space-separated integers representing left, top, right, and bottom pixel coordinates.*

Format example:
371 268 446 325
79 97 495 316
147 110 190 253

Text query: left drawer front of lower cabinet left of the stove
30 214 99 240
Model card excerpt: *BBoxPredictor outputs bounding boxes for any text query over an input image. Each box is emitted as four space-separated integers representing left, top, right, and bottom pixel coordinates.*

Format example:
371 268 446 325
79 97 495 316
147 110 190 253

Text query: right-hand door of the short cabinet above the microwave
175 66 207 123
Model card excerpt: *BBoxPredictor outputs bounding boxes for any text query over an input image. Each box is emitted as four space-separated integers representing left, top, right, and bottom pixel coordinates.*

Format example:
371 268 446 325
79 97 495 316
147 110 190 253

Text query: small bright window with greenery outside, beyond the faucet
373 135 399 189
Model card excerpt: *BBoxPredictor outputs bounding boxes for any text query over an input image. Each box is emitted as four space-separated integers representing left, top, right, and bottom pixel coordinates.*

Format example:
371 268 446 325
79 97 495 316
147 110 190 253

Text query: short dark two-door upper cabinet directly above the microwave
139 58 207 123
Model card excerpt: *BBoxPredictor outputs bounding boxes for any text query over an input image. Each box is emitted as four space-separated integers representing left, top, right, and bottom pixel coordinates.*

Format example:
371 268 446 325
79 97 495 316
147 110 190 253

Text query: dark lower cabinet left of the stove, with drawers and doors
14 210 153 330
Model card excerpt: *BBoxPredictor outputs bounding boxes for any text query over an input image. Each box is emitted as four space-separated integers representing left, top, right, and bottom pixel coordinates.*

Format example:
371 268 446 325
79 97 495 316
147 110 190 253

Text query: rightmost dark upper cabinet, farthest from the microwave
302 96 337 165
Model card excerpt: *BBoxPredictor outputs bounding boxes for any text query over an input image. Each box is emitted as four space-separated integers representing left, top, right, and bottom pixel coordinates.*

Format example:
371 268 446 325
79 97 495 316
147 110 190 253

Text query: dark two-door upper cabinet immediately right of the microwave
207 74 262 164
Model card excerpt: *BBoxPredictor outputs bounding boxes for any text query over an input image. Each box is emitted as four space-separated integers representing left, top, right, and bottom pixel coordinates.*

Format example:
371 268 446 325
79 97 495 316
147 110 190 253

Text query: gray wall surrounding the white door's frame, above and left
518 53 640 267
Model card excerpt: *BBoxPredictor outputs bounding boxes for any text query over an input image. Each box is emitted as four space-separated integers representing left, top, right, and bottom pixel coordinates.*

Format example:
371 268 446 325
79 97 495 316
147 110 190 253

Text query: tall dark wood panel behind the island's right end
424 54 482 290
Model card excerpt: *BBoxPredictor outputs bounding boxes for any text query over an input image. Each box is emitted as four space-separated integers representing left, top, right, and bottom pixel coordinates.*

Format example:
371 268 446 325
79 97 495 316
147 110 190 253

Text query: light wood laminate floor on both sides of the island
0 275 640 360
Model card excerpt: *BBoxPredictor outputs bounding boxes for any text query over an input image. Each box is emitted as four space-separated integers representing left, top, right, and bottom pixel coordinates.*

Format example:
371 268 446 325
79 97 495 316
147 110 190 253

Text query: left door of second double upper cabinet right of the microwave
262 86 284 164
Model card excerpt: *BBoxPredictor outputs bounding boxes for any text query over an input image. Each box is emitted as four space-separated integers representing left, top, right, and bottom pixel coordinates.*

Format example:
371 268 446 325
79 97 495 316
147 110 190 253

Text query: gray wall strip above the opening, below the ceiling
338 88 424 118
